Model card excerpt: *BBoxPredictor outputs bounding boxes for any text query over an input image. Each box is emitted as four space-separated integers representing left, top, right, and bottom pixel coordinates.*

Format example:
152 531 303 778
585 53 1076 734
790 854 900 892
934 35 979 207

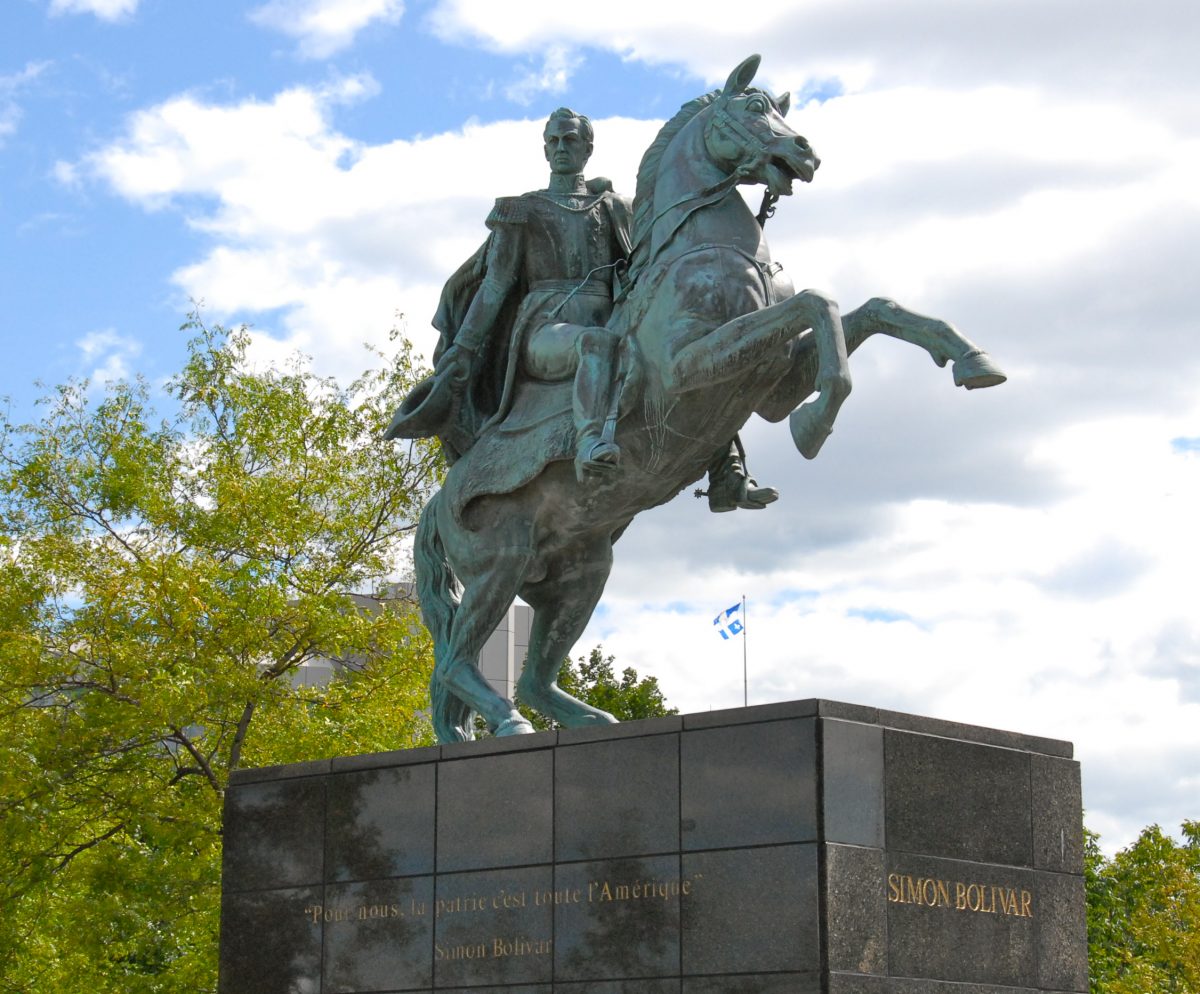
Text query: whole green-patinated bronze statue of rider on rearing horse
389 56 1004 742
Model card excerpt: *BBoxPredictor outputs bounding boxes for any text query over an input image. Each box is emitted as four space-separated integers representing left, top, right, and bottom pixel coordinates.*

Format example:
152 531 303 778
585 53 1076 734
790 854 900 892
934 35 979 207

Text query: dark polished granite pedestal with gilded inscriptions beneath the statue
220 700 1087 994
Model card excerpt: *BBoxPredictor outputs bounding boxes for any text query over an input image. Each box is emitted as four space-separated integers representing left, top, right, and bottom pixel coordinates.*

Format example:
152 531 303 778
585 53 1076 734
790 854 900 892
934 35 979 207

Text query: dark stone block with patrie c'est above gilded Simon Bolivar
433 866 554 988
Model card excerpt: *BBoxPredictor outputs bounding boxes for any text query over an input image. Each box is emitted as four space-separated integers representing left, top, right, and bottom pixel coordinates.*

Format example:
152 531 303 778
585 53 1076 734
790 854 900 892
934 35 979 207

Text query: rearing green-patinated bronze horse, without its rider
415 56 1004 742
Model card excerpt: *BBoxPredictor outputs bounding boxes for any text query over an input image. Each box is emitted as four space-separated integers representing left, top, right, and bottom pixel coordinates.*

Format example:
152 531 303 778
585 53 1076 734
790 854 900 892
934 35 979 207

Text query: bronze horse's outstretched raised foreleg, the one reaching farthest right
842 297 1008 390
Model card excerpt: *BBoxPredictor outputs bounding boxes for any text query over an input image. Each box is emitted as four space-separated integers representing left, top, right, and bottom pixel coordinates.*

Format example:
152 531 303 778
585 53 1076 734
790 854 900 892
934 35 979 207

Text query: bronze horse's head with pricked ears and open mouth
704 55 821 197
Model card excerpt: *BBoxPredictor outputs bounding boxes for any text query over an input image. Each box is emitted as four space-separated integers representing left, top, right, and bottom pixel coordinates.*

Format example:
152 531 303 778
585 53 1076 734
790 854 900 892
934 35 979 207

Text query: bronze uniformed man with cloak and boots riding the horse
388 108 779 511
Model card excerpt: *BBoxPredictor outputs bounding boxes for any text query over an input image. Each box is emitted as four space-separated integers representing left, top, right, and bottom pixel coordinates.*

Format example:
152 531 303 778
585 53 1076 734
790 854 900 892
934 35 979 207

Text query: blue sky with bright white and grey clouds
0 0 1200 851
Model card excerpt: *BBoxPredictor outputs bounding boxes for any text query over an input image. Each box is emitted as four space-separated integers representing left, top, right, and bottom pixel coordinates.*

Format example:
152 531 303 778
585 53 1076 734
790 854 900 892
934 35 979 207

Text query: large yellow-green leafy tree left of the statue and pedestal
0 317 442 994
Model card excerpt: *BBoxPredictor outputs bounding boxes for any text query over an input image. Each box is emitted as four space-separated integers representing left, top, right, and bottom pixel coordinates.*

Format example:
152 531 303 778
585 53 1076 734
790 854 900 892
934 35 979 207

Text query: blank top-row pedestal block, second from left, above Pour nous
325 764 436 880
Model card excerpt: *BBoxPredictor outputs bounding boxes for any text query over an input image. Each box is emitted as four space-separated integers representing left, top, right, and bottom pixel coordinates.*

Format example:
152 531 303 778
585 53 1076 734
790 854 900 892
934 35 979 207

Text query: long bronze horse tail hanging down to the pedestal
413 493 474 742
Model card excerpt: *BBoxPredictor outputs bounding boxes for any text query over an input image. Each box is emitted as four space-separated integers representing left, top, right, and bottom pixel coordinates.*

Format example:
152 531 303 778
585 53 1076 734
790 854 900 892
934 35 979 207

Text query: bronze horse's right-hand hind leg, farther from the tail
517 544 617 727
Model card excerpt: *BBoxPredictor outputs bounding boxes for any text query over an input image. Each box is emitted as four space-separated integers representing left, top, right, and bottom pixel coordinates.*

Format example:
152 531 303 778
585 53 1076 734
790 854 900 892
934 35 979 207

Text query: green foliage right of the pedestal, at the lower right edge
1084 821 1200 994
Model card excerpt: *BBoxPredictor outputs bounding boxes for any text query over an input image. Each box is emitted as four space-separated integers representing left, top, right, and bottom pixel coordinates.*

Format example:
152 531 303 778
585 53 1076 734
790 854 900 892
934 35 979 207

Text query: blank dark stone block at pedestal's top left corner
221 777 325 893
